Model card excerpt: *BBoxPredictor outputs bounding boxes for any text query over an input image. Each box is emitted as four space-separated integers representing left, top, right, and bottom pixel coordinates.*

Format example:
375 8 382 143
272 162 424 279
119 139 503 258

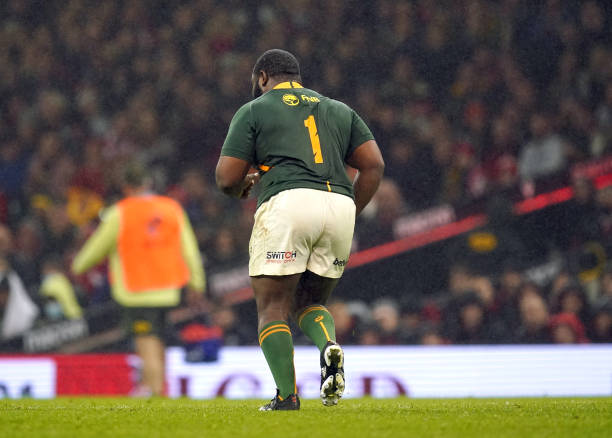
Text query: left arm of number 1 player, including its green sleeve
215 104 259 198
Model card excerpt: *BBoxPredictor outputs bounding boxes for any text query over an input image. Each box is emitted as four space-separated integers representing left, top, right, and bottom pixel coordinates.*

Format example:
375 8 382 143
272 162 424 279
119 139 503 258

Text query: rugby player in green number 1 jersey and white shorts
216 49 384 411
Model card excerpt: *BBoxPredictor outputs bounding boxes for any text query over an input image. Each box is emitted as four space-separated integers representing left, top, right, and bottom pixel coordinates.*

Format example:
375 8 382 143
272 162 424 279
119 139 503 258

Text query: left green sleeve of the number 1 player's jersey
221 103 255 163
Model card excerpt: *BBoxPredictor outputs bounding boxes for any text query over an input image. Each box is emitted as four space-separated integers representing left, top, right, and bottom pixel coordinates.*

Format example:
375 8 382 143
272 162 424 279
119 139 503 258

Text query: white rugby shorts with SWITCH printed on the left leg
249 189 355 278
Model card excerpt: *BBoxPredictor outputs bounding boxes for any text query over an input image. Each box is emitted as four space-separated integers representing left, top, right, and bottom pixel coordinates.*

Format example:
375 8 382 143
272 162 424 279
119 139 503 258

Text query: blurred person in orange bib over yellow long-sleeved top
72 165 206 395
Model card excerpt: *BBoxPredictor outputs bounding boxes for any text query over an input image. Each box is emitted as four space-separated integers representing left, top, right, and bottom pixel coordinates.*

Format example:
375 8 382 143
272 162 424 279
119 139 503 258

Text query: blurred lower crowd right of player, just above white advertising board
318 258 612 345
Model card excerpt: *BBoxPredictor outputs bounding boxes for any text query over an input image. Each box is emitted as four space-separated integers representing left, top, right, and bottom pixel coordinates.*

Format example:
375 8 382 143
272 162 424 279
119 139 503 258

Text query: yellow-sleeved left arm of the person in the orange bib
72 206 120 275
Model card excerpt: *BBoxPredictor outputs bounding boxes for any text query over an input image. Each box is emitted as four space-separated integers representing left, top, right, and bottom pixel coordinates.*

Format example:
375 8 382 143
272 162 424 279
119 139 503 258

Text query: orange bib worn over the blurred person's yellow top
117 196 189 293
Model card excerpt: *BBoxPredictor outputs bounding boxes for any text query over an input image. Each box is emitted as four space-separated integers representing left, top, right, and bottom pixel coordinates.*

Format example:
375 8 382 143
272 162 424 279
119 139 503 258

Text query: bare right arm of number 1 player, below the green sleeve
347 140 385 215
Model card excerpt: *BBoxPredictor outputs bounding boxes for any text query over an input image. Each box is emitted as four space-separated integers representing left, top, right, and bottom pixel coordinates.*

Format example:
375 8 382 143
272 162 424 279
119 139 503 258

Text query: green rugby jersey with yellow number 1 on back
221 82 374 207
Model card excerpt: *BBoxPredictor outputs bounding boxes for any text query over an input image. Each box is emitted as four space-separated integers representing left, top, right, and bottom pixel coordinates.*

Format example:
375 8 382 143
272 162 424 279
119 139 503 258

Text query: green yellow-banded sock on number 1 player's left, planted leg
259 321 297 399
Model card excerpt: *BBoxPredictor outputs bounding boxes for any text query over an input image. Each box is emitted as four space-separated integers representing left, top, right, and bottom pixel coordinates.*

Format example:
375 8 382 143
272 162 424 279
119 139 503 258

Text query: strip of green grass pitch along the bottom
0 398 612 438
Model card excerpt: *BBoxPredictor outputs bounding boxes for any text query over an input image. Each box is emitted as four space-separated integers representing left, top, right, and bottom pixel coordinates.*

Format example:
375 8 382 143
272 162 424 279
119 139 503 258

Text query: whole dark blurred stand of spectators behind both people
0 0 612 352
